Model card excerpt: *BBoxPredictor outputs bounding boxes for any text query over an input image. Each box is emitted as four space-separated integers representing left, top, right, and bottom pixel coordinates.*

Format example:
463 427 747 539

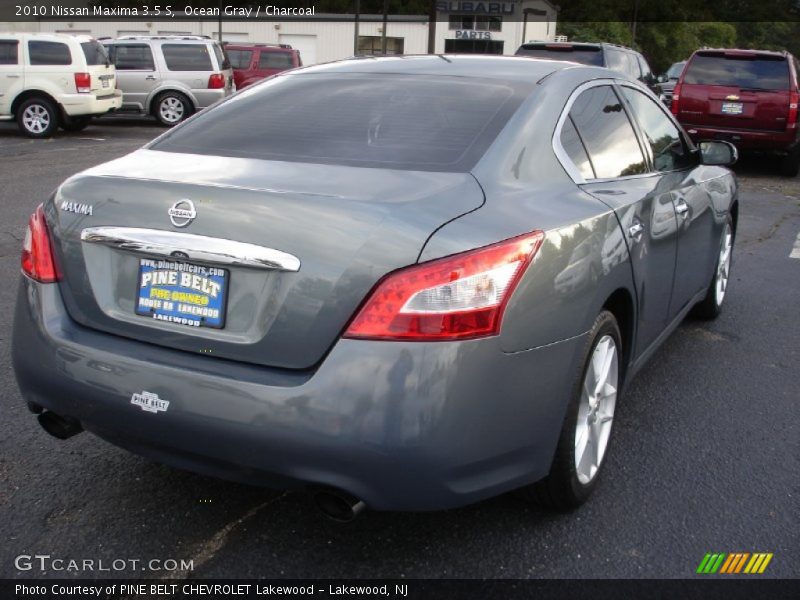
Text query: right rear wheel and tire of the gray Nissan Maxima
528 310 624 511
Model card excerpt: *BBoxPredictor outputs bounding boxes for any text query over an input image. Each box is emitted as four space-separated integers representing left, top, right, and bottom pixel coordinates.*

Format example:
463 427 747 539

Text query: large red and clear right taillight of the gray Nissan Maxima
344 231 544 341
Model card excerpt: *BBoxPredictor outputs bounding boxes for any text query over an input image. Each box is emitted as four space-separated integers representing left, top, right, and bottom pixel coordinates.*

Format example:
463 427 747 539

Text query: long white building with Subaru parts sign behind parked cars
0 0 557 65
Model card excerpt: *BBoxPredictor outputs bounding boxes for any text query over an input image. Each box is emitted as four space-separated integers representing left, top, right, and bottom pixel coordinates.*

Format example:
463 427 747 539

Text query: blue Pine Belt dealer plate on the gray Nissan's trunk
136 258 230 329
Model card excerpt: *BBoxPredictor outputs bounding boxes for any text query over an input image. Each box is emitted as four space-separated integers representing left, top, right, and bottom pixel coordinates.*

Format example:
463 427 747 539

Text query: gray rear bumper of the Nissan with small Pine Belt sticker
13 277 584 510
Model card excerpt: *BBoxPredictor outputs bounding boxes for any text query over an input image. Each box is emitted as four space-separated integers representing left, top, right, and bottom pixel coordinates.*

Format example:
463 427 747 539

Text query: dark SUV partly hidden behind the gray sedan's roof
516 42 656 88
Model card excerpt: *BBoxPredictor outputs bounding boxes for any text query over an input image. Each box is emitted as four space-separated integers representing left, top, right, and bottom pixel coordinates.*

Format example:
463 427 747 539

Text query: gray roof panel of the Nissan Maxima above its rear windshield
292 54 579 83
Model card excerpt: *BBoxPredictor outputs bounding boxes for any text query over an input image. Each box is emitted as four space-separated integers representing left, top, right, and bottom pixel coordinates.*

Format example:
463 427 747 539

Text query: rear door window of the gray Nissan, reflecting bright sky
569 85 647 179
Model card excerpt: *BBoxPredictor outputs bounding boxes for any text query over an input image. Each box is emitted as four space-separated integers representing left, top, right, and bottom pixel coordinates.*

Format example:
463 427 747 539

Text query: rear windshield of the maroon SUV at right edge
683 54 789 90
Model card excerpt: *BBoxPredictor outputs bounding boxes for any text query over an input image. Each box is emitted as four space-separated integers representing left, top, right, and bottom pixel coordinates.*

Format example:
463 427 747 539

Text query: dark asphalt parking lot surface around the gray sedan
0 117 800 578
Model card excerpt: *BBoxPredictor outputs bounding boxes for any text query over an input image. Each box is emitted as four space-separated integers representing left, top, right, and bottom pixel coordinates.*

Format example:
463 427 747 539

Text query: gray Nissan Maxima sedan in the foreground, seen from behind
13 56 738 519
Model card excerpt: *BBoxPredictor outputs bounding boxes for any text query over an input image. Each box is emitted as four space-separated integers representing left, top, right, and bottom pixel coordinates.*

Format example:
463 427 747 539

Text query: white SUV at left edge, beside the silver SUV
0 33 122 138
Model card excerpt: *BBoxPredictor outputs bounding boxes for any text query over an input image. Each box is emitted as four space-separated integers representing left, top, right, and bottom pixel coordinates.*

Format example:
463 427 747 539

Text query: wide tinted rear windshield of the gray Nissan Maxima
151 73 532 172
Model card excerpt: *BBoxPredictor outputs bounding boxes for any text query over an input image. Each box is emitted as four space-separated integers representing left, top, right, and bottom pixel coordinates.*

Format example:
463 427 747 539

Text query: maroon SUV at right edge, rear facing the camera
672 49 800 177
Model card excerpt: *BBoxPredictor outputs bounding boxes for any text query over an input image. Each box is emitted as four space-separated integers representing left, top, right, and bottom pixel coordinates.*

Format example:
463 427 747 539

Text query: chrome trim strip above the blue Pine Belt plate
81 227 300 272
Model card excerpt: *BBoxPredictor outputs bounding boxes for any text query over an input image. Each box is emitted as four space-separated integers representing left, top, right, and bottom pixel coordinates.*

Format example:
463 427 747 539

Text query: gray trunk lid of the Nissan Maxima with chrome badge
47 150 483 369
